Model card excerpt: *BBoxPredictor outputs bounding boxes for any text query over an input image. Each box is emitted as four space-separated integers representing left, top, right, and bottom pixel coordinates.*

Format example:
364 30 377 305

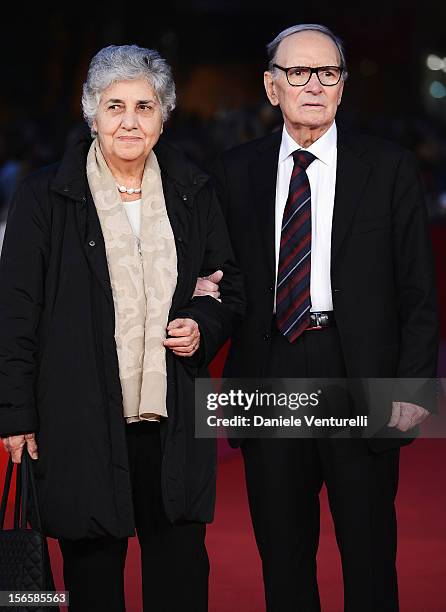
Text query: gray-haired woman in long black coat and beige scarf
0 46 244 612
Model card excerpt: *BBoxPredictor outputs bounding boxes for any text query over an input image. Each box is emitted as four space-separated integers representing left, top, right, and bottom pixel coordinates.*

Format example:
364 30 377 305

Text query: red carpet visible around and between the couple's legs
37 440 446 612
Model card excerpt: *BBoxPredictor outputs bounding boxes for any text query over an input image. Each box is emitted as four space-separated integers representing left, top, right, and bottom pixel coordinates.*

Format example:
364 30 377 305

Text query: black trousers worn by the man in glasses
242 328 399 612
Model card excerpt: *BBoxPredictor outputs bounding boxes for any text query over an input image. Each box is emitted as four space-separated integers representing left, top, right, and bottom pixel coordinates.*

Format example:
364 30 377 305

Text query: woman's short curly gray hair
82 45 176 135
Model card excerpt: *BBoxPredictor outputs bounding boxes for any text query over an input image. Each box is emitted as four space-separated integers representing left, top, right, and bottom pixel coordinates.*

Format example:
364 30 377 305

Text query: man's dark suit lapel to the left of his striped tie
250 131 282 275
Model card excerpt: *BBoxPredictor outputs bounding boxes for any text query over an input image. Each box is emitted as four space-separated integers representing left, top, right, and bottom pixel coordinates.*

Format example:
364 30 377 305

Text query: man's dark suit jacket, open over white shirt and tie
213 125 438 450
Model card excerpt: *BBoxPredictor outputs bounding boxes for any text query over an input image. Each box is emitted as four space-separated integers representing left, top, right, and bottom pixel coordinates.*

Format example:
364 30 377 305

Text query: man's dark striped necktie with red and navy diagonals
276 150 316 342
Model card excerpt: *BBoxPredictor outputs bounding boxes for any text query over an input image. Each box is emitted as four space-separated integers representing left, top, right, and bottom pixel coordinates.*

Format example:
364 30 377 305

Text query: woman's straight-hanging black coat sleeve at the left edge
0 181 50 437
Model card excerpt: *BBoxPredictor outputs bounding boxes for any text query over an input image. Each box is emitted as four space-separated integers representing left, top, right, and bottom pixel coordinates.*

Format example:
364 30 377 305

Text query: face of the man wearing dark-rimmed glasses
264 31 344 135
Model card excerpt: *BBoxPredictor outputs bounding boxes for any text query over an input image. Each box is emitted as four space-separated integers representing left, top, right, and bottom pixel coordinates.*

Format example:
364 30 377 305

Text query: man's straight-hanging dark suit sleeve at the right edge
393 152 439 411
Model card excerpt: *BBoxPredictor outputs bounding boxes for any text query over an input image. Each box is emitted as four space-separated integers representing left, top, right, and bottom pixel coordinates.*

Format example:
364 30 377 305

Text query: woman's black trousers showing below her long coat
59 422 209 612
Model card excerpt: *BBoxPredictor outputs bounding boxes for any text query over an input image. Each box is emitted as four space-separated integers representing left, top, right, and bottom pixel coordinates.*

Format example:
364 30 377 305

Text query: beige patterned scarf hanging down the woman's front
87 139 177 422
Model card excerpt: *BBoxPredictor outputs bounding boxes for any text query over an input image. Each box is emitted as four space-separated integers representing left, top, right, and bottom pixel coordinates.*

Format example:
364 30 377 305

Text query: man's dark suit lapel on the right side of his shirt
331 135 370 260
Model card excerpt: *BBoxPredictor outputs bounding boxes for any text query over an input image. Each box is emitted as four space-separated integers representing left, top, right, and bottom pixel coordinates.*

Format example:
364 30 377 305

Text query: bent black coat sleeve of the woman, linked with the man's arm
175 184 245 368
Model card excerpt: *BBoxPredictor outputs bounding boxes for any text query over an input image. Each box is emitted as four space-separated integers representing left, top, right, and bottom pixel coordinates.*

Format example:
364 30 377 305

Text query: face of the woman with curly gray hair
93 78 163 163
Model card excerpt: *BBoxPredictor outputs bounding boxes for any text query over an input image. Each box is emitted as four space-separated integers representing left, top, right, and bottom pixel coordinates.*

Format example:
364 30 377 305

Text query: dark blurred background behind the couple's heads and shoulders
0 0 446 221
